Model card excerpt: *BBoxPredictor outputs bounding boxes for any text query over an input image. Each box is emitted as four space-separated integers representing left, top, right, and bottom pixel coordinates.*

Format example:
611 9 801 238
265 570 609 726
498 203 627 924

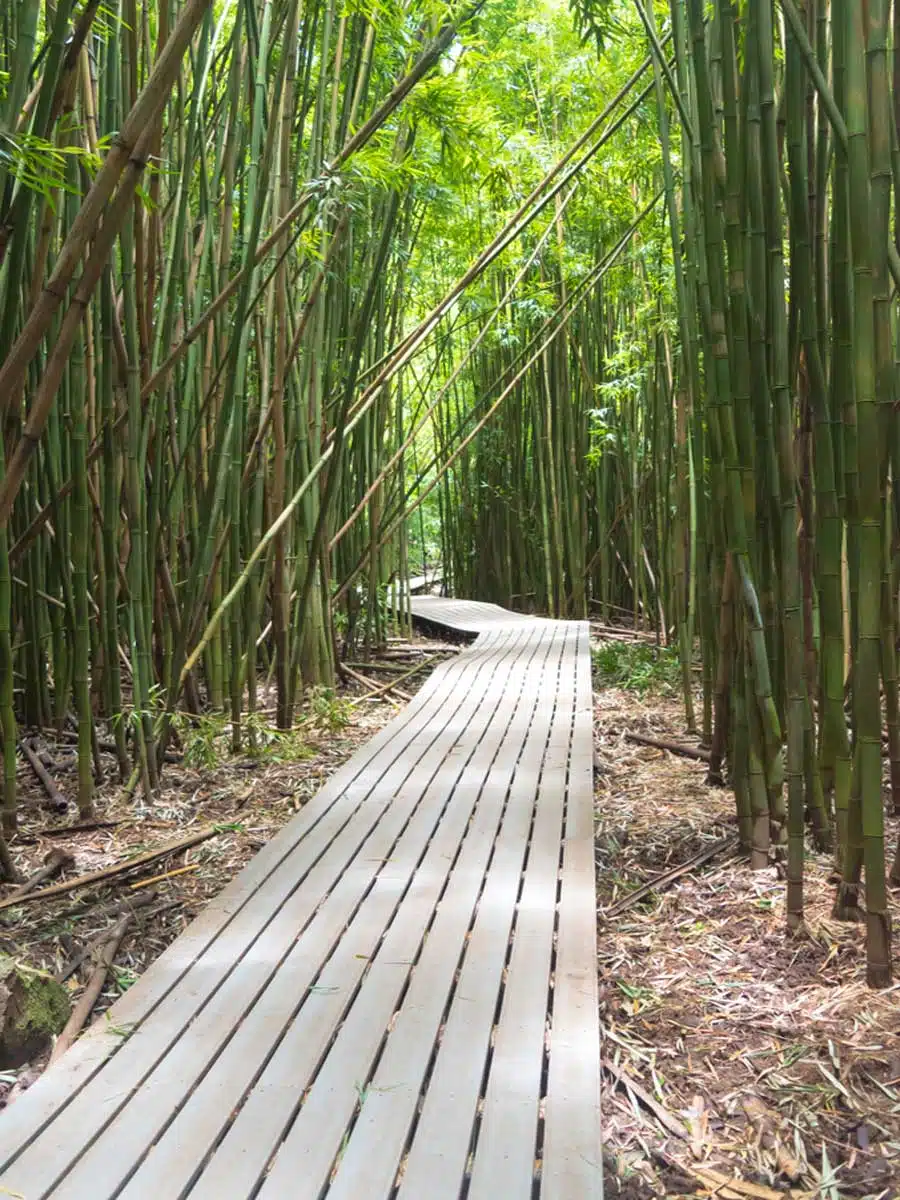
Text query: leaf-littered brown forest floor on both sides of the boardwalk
0 637 900 1200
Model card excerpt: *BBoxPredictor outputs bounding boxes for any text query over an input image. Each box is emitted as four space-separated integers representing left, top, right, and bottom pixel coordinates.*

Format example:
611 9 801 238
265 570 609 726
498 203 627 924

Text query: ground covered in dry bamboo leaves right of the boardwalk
594 650 900 1200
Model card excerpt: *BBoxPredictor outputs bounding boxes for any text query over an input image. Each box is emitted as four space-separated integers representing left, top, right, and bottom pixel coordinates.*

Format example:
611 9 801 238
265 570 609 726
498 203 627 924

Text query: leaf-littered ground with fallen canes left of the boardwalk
0 636 457 1110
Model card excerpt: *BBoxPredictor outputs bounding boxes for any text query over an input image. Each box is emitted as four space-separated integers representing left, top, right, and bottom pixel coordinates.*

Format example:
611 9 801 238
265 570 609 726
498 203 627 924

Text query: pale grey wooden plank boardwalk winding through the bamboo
0 596 602 1200
